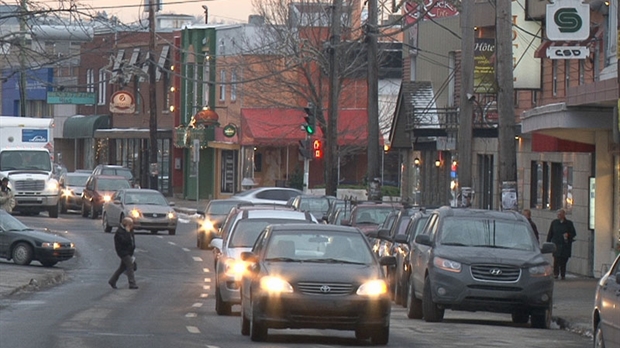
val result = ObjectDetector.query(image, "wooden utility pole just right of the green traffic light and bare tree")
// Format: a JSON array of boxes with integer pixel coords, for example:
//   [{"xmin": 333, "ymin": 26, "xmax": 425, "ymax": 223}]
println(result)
[{"xmin": 366, "ymin": 0, "xmax": 381, "ymax": 199}]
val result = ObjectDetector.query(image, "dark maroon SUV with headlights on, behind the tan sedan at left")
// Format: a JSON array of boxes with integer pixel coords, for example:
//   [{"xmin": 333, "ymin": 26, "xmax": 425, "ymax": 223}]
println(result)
[{"xmin": 82, "ymin": 175, "xmax": 130, "ymax": 219}]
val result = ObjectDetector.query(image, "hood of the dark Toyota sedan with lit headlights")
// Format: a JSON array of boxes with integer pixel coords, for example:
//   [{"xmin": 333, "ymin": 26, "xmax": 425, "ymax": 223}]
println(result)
[{"xmin": 265, "ymin": 262, "xmax": 383, "ymax": 284}]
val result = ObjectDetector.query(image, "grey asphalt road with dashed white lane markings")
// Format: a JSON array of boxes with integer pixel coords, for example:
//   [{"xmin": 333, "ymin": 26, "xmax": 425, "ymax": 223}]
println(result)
[{"xmin": 0, "ymin": 214, "xmax": 592, "ymax": 348}]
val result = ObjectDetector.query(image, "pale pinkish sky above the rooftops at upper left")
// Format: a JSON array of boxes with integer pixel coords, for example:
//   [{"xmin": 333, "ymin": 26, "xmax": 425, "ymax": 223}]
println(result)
[{"xmin": 79, "ymin": 0, "xmax": 253, "ymax": 23}]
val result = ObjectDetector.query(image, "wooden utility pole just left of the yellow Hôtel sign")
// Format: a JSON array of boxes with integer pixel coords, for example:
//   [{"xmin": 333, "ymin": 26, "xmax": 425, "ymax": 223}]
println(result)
[{"xmin": 458, "ymin": 0, "xmax": 474, "ymax": 206}]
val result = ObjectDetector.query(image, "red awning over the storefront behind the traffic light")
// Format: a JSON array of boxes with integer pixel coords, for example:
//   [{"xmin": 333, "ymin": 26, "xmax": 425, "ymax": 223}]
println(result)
[{"xmin": 240, "ymin": 108, "xmax": 370, "ymax": 146}]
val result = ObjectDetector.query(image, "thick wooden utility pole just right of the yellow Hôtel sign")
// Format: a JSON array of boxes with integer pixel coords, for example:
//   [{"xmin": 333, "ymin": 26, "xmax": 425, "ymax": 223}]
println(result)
[{"xmin": 495, "ymin": 0, "xmax": 517, "ymax": 201}]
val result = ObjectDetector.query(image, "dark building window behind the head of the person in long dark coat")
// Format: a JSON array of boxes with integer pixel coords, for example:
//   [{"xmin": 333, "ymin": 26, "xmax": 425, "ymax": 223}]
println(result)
[{"xmin": 530, "ymin": 161, "xmax": 573, "ymax": 212}]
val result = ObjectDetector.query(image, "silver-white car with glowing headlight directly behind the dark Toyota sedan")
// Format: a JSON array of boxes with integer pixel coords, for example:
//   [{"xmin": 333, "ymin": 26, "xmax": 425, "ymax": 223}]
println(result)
[{"xmin": 211, "ymin": 206, "xmax": 318, "ymax": 315}]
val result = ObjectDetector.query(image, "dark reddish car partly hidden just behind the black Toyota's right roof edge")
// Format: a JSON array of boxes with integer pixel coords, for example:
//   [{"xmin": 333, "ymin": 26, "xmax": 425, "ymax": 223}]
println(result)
[{"xmin": 340, "ymin": 201, "xmax": 402, "ymax": 235}]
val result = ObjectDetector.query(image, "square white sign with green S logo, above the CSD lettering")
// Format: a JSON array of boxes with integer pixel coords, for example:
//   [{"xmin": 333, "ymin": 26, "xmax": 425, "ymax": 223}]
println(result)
[{"xmin": 547, "ymin": 0, "xmax": 590, "ymax": 41}]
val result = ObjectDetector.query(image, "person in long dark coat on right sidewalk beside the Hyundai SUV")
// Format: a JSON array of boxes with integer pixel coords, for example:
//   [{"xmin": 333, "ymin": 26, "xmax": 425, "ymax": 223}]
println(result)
[{"xmin": 547, "ymin": 209, "xmax": 577, "ymax": 279}]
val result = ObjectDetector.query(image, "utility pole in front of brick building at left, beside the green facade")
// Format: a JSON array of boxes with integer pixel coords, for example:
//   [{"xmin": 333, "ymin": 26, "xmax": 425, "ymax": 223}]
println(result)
[{"xmin": 149, "ymin": 0, "xmax": 159, "ymax": 190}]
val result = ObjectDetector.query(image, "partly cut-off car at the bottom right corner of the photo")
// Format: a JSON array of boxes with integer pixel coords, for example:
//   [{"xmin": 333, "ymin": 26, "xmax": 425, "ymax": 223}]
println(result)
[{"xmin": 592, "ymin": 255, "xmax": 620, "ymax": 348}]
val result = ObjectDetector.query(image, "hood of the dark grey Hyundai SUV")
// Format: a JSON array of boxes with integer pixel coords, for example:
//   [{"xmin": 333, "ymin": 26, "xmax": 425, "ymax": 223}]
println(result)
[{"xmin": 434, "ymin": 246, "xmax": 547, "ymax": 267}]
